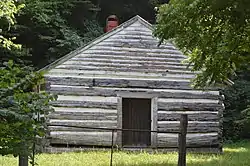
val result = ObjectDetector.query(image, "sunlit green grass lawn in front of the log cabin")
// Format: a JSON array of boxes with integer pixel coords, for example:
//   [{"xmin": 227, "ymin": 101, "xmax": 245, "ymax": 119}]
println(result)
[{"xmin": 0, "ymin": 142, "xmax": 250, "ymax": 166}]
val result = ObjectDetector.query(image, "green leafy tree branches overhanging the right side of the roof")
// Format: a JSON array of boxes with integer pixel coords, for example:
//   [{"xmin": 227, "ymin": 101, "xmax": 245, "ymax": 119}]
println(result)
[{"xmin": 155, "ymin": 0, "xmax": 250, "ymax": 87}]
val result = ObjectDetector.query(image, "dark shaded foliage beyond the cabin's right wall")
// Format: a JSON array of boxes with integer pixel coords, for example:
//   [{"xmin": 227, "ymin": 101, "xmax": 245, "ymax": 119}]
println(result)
[{"xmin": 223, "ymin": 74, "xmax": 250, "ymax": 141}]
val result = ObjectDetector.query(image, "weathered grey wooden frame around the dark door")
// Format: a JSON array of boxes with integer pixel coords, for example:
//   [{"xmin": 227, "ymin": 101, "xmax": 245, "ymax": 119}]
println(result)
[{"xmin": 116, "ymin": 92, "xmax": 158, "ymax": 148}]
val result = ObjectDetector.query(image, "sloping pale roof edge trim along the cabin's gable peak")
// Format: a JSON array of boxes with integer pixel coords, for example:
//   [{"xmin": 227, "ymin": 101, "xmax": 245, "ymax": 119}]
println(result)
[{"xmin": 40, "ymin": 15, "xmax": 153, "ymax": 71}]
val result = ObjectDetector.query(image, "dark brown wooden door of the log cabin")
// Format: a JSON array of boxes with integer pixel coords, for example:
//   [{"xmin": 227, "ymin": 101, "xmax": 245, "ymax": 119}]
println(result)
[{"xmin": 122, "ymin": 98, "xmax": 151, "ymax": 147}]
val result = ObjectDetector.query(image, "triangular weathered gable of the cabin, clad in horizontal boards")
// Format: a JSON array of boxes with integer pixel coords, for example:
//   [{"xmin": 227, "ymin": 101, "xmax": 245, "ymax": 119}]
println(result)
[{"xmin": 44, "ymin": 16, "xmax": 195, "ymax": 85}]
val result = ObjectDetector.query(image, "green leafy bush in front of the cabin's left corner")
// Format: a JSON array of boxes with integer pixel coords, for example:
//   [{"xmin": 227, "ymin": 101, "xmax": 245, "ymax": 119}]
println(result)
[{"xmin": 0, "ymin": 61, "xmax": 55, "ymax": 159}]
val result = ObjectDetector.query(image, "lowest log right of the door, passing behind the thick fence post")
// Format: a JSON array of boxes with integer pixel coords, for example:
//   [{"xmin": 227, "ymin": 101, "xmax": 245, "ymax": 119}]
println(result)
[{"xmin": 157, "ymin": 133, "xmax": 219, "ymax": 148}]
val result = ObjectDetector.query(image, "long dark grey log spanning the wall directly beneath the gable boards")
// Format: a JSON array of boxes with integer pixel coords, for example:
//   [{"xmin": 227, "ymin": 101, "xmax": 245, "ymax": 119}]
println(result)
[{"xmin": 46, "ymin": 77, "xmax": 192, "ymax": 89}]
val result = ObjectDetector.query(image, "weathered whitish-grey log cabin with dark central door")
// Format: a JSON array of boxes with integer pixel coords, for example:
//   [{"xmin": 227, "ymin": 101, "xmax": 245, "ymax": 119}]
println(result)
[{"xmin": 44, "ymin": 16, "xmax": 224, "ymax": 152}]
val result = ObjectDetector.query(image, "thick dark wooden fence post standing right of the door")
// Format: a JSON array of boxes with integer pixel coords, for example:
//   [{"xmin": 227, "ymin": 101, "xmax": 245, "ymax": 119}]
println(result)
[{"xmin": 178, "ymin": 114, "xmax": 188, "ymax": 166}]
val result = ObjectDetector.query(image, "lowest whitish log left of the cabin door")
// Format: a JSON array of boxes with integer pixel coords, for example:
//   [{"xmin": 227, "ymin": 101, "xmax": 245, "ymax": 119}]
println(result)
[{"xmin": 50, "ymin": 132, "xmax": 117, "ymax": 146}]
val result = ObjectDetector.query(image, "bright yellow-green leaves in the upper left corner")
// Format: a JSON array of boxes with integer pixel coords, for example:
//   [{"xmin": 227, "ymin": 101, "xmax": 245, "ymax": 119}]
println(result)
[{"xmin": 0, "ymin": 0, "xmax": 24, "ymax": 50}]
